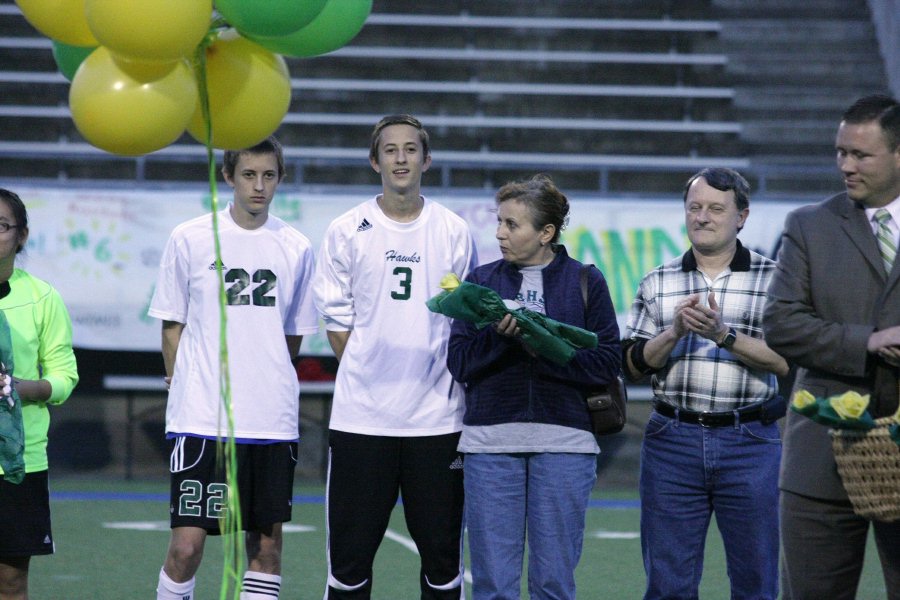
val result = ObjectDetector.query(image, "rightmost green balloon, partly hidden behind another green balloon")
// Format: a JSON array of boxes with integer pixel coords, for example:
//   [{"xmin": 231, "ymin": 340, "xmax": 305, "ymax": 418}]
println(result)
[{"xmin": 248, "ymin": 0, "xmax": 372, "ymax": 57}]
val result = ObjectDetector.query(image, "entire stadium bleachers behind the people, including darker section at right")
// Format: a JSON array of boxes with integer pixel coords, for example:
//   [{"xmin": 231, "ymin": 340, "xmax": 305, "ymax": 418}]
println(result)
[{"xmin": 0, "ymin": 0, "xmax": 885, "ymax": 194}]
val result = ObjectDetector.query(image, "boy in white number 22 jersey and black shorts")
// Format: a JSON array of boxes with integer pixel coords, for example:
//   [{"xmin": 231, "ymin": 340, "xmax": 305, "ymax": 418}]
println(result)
[{"xmin": 149, "ymin": 137, "xmax": 318, "ymax": 600}]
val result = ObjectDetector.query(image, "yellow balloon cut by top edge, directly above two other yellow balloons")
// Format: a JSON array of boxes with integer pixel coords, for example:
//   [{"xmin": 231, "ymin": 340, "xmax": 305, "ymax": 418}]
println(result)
[{"xmin": 85, "ymin": 0, "xmax": 212, "ymax": 61}]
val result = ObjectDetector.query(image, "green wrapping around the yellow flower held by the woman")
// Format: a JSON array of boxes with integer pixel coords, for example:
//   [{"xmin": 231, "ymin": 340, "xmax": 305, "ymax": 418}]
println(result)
[{"xmin": 425, "ymin": 281, "xmax": 597, "ymax": 365}]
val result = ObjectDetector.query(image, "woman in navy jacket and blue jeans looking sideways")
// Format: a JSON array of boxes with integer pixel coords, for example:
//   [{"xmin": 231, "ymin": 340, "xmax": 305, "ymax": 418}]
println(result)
[{"xmin": 448, "ymin": 175, "xmax": 620, "ymax": 600}]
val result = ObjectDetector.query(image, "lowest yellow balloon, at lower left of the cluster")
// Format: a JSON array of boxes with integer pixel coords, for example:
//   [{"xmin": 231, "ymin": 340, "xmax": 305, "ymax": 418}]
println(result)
[{"xmin": 69, "ymin": 46, "xmax": 197, "ymax": 156}]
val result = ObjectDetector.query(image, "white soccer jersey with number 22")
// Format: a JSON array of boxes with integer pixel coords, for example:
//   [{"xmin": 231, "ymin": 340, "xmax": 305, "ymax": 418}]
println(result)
[{"xmin": 148, "ymin": 207, "xmax": 318, "ymax": 440}]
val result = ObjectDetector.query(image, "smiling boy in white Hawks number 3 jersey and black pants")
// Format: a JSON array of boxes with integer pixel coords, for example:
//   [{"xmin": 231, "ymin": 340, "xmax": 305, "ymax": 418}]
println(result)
[{"xmin": 313, "ymin": 115, "xmax": 476, "ymax": 599}]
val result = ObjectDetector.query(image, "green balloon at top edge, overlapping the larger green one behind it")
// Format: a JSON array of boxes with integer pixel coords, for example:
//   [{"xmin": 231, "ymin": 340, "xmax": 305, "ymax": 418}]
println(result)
[{"xmin": 216, "ymin": 0, "xmax": 327, "ymax": 37}]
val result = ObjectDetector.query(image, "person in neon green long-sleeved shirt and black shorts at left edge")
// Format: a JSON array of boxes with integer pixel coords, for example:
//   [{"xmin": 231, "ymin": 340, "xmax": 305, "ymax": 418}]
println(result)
[{"xmin": 0, "ymin": 188, "xmax": 78, "ymax": 600}]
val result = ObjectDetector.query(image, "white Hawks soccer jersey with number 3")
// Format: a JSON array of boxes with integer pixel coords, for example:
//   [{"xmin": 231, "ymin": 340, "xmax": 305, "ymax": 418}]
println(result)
[{"xmin": 313, "ymin": 198, "xmax": 476, "ymax": 436}]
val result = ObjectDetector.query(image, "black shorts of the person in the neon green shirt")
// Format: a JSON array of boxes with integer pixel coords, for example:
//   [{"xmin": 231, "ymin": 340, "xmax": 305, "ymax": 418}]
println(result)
[{"xmin": 0, "ymin": 471, "xmax": 54, "ymax": 558}]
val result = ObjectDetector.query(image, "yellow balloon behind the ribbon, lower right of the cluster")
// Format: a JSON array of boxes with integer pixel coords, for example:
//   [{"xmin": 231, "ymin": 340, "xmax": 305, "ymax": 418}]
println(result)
[{"xmin": 188, "ymin": 29, "xmax": 291, "ymax": 150}]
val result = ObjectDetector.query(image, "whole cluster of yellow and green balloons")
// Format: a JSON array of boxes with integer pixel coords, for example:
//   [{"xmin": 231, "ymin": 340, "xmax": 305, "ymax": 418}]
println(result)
[{"xmin": 15, "ymin": 0, "xmax": 372, "ymax": 156}]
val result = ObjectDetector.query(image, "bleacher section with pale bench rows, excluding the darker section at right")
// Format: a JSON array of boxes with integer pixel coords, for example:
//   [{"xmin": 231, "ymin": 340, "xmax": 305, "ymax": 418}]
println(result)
[{"xmin": 0, "ymin": 1, "xmax": 746, "ymax": 189}]
